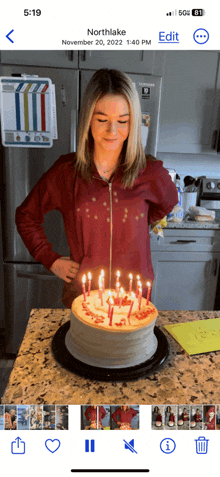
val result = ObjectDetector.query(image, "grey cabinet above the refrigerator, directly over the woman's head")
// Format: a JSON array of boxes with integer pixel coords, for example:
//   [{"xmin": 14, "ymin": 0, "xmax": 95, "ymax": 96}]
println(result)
[{"xmin": 79, "ymin": 50, "xmax": 165, "ymax": 76}]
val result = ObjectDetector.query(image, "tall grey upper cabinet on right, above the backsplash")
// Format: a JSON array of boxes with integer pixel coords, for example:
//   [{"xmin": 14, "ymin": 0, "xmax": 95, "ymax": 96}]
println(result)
[{"xmin": 157, "ymin": 51, "xmax": 220, "ymax": 154}]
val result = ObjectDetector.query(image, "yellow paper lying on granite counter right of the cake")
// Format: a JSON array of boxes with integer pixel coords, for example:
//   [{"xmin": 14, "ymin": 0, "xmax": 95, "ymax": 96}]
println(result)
[{"xmin": 164, "ymin": 318, "xmax": 220, "ymax": 355}]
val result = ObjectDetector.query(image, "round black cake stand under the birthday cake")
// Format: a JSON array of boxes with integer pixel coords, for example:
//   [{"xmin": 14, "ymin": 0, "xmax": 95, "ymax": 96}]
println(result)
[{"xmin": 52, "ymin": 321, "xmax": 169, "ymax": 382}]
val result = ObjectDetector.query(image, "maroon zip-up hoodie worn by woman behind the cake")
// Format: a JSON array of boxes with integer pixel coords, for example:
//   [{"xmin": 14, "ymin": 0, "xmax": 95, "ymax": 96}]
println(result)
[{"xmin": 16, "ymin": 153, "xmax": 178, "ymax": 307}]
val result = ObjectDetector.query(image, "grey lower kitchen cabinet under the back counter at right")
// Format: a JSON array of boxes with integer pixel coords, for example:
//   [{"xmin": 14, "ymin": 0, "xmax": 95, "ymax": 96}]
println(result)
[{"xmin": 151, "ymin": 229, "xmax": 220, "ymax": 311}]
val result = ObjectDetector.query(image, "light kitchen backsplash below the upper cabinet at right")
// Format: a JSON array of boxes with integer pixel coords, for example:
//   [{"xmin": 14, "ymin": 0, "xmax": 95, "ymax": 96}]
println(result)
[{"xmin": 157, "ymin": 152, "xmax": 220, "ymax": 189}]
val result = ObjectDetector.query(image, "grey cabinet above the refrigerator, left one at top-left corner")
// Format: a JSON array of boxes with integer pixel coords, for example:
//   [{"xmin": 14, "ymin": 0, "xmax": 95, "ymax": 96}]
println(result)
[{"xmin": 1, "ymin": 50, "xmax": 78, "ymax": 68}]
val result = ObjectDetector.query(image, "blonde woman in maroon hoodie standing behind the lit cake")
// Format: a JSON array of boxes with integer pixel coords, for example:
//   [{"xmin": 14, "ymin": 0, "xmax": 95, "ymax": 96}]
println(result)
[{"xmin": 16, "ymin": 69, "xmax": 178, "ymax": 307}]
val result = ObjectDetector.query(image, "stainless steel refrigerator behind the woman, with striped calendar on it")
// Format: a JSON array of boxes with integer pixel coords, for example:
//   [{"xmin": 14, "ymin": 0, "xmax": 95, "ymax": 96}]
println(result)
[{"xmin": 0, "ymin": 60, "xmax": 161, "ymax": 353}]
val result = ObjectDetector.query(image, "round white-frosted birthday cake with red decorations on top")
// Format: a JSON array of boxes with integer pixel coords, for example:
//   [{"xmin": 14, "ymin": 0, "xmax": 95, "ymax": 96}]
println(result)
[{"xmin": 65, "ymin": 290, "xmax": 158, "ymax": 368}]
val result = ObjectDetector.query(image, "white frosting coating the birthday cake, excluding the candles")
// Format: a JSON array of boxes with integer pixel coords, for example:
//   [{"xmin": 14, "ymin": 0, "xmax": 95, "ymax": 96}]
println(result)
[{"xmin": 65, "ymin": 286, "xmax": 157, "ymax": 368}]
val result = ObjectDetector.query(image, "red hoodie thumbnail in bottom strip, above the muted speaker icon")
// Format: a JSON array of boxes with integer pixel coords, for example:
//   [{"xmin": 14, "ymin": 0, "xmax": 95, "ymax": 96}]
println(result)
[{"xmin": 111, "ymin": 405, "xmax": 139, "ymax": 431}]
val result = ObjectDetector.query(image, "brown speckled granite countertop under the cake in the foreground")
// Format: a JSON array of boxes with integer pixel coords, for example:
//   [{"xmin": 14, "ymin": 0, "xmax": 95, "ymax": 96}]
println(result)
[{"xmin": 2, "ymin": 309, "xmax": 220, "ymax": 405}]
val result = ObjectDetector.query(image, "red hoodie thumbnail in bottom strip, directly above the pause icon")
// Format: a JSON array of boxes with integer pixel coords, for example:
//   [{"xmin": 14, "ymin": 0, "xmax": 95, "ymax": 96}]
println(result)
[{"xmin": 81, "ymin": 405, "xmax": 110, "ymax": 431}]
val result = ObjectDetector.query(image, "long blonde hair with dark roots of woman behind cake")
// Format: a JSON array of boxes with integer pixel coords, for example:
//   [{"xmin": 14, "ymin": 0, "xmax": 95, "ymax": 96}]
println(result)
[{"xmin": 76, "ymin": 68, "xmax": 146, "ymax": 188}]
